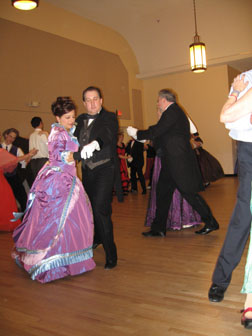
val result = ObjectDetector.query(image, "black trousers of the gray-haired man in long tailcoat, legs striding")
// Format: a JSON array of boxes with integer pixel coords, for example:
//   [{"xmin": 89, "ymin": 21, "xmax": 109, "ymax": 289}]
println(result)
[{"xmin": 151, "ymin": 163, "xmax": 213, "ymax": 232}]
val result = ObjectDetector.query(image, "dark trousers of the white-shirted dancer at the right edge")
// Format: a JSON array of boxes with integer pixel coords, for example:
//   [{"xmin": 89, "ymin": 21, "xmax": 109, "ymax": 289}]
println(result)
[{"xmin": 212, "ymin": 142, "xmax": 252, "ymax": 288}]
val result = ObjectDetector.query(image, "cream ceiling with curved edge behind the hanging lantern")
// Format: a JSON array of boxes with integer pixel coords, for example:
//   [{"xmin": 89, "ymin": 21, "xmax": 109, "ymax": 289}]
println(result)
[{"xmin": 41, "ymin": 0, "xmax": 252, "ymax": 77}]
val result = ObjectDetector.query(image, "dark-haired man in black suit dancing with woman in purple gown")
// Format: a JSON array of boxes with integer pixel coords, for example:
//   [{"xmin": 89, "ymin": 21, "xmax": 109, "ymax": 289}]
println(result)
[{"xmin": 74, "ymin": 87, "xmax": 122, "ymax": 269}]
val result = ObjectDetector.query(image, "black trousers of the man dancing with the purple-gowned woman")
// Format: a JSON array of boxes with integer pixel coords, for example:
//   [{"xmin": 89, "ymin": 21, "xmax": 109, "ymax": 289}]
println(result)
[{"xmin": 82, "ymin": 163, "xmax": 117, "ymax": 262}]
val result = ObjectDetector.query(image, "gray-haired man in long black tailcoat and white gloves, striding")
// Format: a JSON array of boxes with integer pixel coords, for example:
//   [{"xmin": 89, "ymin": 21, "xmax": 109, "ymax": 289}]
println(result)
[{"xmin": 127, "ymin": 89, "xmax": 219, "ymax": 237}]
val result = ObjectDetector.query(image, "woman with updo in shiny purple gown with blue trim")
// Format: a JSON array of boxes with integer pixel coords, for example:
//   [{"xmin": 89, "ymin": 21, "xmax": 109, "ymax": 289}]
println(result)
[{"xmin": 13, "ymin": 97, "xmax": 95, "ymax": 283}]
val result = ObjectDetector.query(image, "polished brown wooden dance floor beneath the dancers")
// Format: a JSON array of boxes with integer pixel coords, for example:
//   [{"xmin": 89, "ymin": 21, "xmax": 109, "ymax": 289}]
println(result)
[{"xmin": 0, "ymin": 177, "xmax": 249, "ymax": 336}]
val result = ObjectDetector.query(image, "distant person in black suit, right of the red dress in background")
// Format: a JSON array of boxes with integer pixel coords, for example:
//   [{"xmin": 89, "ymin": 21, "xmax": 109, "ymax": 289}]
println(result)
[{"xmin": 126, "ymin": 139, "xmax": 146, "ymax": 194}]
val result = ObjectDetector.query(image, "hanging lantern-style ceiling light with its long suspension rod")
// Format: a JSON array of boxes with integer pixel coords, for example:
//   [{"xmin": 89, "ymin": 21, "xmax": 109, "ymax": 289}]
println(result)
[{"xmin": 189, "ymin": 0, "xmax": 207, "ymax": 73}]
